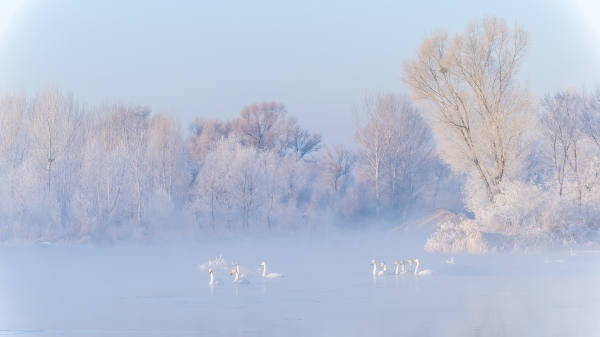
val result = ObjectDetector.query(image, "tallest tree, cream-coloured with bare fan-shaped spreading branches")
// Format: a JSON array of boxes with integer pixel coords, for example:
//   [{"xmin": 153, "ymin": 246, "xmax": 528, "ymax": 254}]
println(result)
[{"xmin": 402, "ymin": 17, "xmax": 534, "ymax": 200}]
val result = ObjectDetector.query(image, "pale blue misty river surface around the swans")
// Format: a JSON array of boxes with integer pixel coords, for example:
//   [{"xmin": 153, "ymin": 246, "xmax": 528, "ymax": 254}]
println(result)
[{"xmin": 0, "ymin": 234, "xmax": 600, "ymax": 337}]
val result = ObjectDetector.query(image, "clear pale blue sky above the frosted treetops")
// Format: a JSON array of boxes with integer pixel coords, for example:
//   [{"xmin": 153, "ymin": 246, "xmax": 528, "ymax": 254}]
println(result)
[{"xmin": 0, "ymin": 0, "xmax": 600, "ymax": 143}]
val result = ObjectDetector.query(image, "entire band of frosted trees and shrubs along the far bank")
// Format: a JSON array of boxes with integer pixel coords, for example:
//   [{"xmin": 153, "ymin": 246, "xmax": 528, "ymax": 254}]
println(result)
[{"xmin": 0, "ymin": 17, "xmax": 600, "ymax": 252}]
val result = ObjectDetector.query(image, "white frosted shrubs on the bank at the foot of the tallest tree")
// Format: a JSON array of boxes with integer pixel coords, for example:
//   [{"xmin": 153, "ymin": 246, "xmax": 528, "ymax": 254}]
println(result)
[{"xmin": 434, "ymin": 181, "xmax": 584, "ymax": 253}]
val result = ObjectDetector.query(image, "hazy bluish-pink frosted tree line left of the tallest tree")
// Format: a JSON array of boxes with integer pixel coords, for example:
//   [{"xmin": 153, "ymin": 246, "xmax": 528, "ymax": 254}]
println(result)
[{"xmin": 0, "ymin": 86, "xmax": 443, "ymax": 242}]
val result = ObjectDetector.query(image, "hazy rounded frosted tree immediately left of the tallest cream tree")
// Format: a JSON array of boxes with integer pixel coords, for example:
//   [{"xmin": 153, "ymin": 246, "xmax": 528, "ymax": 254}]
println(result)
[{"xmin": 355, "ymin": 93, "xmax": 433, "ymax": 215}]
